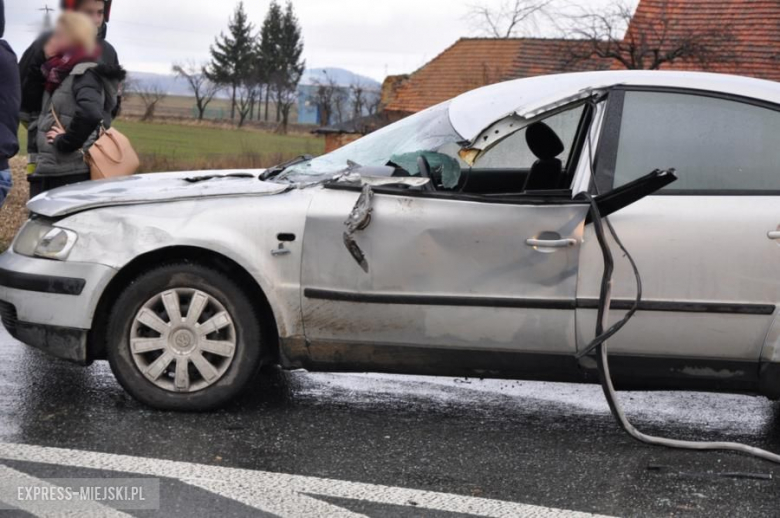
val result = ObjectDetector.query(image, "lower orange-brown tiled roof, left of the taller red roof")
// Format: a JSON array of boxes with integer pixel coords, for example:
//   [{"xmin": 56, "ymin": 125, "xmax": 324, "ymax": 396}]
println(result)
[{"xmin": 385, "ymin": 38, "xmax": 610, "ymax": 113}]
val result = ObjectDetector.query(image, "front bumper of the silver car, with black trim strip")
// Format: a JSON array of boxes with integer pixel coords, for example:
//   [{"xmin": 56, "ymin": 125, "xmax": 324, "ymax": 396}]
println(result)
[{"xmin": 0, "ymin": 251, "xmax": 116, "ymax": 364}]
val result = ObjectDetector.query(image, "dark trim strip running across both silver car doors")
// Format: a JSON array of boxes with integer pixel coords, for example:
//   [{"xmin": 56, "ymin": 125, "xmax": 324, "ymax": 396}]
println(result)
[{"xmin": 303, "ymin": 288, "xmax": 775, "ymax": 315}]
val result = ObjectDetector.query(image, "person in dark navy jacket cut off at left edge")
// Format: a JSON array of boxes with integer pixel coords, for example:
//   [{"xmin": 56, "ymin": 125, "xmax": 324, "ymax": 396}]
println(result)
[{"xmin": 0, "ymin": 0, "xmax": 22, "ymax": 207}]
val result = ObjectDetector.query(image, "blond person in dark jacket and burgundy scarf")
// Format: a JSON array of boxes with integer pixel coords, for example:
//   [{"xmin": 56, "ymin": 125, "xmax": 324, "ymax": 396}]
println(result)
[{"xmin": 29, "ymin": 12, "xmax": 125, "ymax": 197}]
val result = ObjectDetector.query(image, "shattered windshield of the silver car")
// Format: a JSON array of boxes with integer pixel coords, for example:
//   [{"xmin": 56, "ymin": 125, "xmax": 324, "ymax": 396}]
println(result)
[{"xmin": 285, "ymin": 102, "xmax": 464, "ymax": 181}]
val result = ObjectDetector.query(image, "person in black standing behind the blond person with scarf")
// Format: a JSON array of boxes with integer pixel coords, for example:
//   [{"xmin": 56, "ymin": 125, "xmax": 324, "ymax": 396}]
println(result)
[{"xmin": 19, "ymin": 0, "xmax": 121, "ymax": 183}]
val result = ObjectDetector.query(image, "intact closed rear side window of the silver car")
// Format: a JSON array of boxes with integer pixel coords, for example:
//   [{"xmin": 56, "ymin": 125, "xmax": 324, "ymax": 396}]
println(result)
[{"xmin": 614, "ymin": 91, "xmax": 780, "ymax": 194}]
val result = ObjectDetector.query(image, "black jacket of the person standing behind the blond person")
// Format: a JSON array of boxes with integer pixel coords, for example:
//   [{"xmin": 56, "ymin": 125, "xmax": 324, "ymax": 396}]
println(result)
[{"xmin": 19, "ymin": 31, "xmax": 119, "ymax": 122}]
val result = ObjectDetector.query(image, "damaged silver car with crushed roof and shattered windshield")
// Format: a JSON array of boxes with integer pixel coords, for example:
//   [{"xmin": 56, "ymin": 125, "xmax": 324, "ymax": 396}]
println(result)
[{"xmin": 0, "ymin": 72, "xmax": 780, "ymax": 410}]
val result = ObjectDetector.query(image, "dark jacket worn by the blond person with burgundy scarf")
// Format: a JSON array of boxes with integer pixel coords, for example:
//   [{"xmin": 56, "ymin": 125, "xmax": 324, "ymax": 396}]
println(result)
[{"xmin": 54, "ymin": 63, "xmax": 127, "ymax": 153}]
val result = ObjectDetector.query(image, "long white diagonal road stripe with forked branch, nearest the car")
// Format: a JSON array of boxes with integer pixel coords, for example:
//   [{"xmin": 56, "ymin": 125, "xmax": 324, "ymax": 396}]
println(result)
[{"xmin": 0, "ymin": 443, "xmax": 612, "ymax": 518}]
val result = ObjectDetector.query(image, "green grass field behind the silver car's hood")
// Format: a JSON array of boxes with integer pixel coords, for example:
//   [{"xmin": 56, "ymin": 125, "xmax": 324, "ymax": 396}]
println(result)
[{"xmin": 19, "ymin": 120, "xmax": 325, "ymax": 172}]
